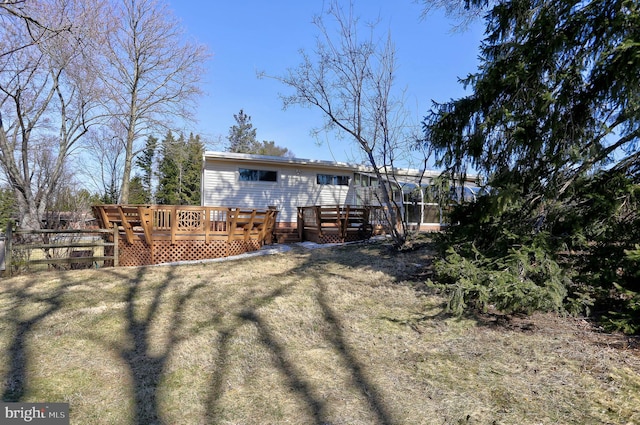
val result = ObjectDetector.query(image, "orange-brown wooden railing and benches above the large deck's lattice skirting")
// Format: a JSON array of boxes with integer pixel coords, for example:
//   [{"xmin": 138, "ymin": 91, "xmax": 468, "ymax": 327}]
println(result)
[{"xmin": 93, "ymin": 205, "xmax": 277, "ymax": 245}]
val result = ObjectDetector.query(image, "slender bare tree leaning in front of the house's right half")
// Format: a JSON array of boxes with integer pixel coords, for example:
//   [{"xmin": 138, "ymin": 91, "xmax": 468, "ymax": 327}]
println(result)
[{"xmin": 264, "ymin": 2, "xmax": 415, "ymax": 248}]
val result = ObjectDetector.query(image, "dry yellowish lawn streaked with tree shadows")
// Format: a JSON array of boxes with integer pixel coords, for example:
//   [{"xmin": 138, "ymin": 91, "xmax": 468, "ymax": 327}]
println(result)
[{"xmin": 0, "ymin": 238, "xmax": 640, "ymax": 425}]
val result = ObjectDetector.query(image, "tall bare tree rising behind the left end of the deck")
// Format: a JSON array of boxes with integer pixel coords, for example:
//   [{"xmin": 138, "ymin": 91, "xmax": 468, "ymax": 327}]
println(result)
[{"xmin": 104, "ymin": 0, "xmax": 209, "ymax": 203}]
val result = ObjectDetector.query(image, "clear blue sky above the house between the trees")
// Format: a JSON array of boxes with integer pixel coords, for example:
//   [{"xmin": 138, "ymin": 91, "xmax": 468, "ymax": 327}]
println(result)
[{"xmin": 168, "ymin": 0, "xmax": 482, "ymax": 166}]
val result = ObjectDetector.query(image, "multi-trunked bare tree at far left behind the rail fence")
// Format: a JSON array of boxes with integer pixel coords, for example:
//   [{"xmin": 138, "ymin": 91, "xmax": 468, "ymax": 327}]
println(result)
[{"xmin": 0, "ymin": 0, "xmax": 109, "ymax": 228}]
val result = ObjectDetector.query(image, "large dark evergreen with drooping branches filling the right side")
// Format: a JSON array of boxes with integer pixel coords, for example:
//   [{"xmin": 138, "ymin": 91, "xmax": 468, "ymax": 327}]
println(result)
[{"xmin": 425, "ymin": 0, "xmax": 640, "ymax": 329}]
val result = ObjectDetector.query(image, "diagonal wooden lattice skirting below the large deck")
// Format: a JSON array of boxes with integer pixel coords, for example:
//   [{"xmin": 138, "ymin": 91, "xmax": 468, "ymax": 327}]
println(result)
[{"xmin": 118, "ymin": 237, "xmax": 260, "ymax": 267}]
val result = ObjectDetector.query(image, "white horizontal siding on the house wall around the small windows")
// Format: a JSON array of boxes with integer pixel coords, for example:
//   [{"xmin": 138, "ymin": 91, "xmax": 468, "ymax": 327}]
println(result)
[{"xmin": 202, "ymin": 158, "xmax": 354, "ymax": 222}]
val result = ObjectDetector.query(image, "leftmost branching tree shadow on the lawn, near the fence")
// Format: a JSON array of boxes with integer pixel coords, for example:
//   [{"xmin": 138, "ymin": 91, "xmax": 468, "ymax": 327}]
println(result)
[{"xmin": 2, "ymin": 275, "xmax": 69, "ymax": 402}]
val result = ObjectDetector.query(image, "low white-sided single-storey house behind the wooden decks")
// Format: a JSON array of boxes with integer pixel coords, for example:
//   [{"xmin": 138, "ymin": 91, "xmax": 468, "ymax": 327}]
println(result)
[{"xmin": 201, "ymin": 151, "xmax": 478, "ymax": 238}]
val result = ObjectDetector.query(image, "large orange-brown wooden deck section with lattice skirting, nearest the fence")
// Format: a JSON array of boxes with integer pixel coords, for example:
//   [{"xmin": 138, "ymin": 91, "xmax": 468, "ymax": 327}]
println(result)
[{"xmin": 93, "ymin": 205, "xmax": 278, "ymax": 266}]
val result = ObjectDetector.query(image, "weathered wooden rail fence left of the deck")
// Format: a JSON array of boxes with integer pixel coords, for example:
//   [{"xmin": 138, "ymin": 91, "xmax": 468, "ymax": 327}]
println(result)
[{"xmin": 4, "ymin": 224, "xmax": 118, "ymax": 276}]
